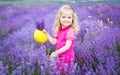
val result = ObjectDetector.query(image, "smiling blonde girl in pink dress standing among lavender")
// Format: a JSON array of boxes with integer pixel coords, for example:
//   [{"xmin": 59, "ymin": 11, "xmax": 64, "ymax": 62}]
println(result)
[{"xmin": 47, "ymin": 5, "xmax": 78, "ymax": 69}]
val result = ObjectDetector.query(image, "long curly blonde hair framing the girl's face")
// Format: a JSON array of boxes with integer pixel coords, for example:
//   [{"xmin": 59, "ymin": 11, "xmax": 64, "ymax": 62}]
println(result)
[{"xmin": 53, "ymin": 5, "xmax": 79, "ymax": 35}]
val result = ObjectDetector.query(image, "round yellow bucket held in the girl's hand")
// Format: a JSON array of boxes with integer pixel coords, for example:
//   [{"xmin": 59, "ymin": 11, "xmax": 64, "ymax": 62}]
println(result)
[{"xmin": 34, "ymin": 29, "xmax": 48, "ymax": 44}]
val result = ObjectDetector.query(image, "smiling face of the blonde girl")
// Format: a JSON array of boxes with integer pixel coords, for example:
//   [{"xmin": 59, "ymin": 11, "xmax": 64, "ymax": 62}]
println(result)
[{"xmin": 60, "ymin": 10, "xmax": 73, "ymax": 28}]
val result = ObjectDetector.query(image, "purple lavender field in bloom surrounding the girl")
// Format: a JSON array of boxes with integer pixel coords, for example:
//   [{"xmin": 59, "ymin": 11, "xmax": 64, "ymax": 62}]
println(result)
[{"xmin": 0, "ymin": 3, "xmax": 120, "ymax": 75}]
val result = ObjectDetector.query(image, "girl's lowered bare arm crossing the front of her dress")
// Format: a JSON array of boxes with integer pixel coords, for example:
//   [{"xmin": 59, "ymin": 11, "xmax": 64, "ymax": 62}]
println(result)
[{"xmin": 50, "ymin": 40, "xmax": 72, "ymax": 58}]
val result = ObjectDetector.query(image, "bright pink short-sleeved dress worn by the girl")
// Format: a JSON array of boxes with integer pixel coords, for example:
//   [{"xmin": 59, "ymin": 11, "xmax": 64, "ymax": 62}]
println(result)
[{"xmin": 56, "ymin": 26, "xmax": 76, "ymax": 69}]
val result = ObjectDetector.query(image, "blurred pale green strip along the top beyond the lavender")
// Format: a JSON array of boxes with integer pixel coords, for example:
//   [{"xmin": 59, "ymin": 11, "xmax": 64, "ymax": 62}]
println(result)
[{"xmin": 0, "ymin": 0, "xmax": 120, "ymax": 4}]
